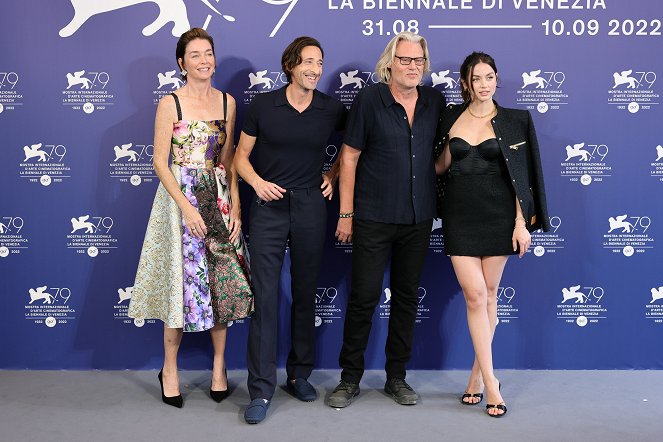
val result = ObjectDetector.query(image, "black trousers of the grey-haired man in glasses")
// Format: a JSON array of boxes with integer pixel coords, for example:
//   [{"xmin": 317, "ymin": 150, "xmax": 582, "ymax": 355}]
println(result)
[{"xmin": 339, "ymin": 219, "xmax": 432, "ymax": 383}]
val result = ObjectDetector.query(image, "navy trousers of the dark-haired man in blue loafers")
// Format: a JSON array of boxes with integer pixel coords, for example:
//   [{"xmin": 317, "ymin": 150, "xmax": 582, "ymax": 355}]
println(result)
[{"xmin": 247, "ymin": 188, "xmax": 327, "ymax": 400}]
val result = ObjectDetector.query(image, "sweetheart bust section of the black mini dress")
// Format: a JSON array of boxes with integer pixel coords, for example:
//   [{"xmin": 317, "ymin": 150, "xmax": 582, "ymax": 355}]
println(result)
[{"xmin": 449, "ymin": 137, "xmax": 507, "ymax": 175}]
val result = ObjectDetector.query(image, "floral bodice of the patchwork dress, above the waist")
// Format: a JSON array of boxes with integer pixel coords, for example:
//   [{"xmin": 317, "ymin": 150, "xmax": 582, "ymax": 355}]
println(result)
[{"xmin": 171, "ymin": 120, "xmax": 226, "ymax": 169}]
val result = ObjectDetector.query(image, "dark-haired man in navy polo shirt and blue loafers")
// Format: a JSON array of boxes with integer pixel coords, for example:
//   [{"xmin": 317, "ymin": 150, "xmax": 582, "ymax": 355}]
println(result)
[{"xmin": 234, "ymin": 37, "xmax": 346, "ymax": 424}]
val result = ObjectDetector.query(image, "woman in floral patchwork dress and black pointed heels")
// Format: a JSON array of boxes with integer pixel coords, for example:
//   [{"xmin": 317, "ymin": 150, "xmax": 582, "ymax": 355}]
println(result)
[{"xmin": 129, "ymin": 28, "xmax": 253, "ymax": 407}]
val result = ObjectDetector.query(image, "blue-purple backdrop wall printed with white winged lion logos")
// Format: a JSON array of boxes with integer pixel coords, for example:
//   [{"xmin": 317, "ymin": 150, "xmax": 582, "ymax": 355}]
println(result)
[{"xmin": 0, "ymin": 0, "xmax": 663, "ymax": 369}]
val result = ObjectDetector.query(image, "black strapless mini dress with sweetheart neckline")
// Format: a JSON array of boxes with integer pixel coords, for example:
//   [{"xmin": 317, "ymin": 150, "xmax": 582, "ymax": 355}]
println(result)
[{"xmin": 442, "ymin": 137, "xmax": 516, "ymax": 256}]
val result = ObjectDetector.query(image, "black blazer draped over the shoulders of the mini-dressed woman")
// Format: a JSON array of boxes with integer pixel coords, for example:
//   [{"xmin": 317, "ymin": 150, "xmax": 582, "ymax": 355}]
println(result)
[{"xmin": 436, "ymin": 103, "xmax": 550, "ymax": 232}]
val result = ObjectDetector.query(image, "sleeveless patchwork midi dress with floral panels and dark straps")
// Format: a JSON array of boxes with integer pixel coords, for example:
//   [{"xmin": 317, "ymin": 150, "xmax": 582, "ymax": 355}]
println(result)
[{"xmin": 128, "ymin": 93, "xmax": 253, "ymax": 331}]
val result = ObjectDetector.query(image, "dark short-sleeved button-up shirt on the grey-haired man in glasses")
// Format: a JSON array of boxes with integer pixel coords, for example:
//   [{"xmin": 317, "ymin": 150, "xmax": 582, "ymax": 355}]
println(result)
[{"xmin": 343, "ymin": 83, "xmax": 445, "ymax": 224}]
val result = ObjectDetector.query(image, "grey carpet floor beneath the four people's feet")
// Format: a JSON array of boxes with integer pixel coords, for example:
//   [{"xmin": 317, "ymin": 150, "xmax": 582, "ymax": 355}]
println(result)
[{"xmin": 0, "ymin": 370, "xmax": 663, "ymax": 442}]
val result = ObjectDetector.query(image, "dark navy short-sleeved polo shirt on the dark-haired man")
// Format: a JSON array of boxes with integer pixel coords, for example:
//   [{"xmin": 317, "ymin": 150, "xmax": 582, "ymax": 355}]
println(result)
[{"xmin": 242, "ymin": 86, "xmax": 347, "ymax": 190}]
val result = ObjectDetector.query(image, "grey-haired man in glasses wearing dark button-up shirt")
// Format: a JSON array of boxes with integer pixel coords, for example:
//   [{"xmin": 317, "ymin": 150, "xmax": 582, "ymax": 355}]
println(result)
[{"xmin": 327, "ymin": 32, "xmax": 444, "ymax": 408}]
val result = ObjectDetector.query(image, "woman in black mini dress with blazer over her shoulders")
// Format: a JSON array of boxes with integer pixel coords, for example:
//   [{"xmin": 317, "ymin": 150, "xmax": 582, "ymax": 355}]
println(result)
[{"xmin": 435, "ymin": 52, "xmax": 549, "ymax": 417}]
